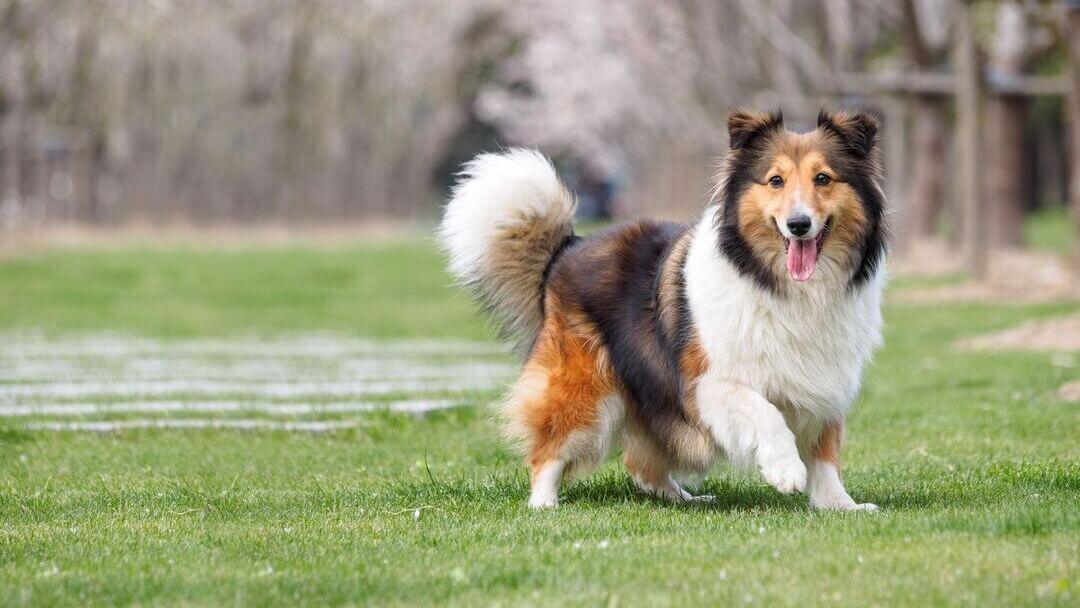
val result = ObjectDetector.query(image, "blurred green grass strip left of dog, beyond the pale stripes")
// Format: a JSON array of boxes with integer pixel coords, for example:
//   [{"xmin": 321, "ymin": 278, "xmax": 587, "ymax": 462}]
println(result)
[{"xmin": 0, "ymin": 241, "xmax": 486, "ymax": 338}]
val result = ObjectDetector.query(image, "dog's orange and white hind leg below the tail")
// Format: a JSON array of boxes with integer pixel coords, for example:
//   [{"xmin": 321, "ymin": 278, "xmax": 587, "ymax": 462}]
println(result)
[{"xmin": 507, "ymin": 314, "xmax": 623, "ymax": 509}]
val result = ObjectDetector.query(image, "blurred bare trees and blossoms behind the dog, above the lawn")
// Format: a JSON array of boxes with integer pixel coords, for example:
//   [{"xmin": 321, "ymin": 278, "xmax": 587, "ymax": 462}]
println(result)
[{"xmin": 0, "ymin": 0, "xmax": 1080, "ymax": 278}]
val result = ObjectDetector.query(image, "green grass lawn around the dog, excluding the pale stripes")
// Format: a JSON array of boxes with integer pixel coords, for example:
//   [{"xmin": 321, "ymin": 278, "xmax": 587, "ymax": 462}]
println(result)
[{"xmin": 0, "ymin": 234, "xmax": 1080, "ymax": 606}]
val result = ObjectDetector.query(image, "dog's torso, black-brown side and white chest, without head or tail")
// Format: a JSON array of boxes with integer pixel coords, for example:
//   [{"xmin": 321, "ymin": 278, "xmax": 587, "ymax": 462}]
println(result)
[{"xmin": 545, "ymin": 214, "xmax": 881, "ymax": 474}]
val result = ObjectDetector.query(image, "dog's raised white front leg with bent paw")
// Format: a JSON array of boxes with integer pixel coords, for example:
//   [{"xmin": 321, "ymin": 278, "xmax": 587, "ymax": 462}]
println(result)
[{"xmin": 696, "ymin": 374, "xmax": 807, "ymax": 494}]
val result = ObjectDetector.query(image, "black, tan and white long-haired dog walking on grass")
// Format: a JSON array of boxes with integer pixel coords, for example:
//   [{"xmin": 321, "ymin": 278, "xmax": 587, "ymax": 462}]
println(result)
[{"xmin": 438, "ymin": 109, "xmax": 887, "ymax": 510}]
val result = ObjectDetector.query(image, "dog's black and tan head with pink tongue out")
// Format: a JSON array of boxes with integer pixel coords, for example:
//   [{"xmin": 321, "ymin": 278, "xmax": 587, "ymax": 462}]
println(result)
[{"xmin": 716, "ymin": 110, "xmax": 885, "ymax": 293}]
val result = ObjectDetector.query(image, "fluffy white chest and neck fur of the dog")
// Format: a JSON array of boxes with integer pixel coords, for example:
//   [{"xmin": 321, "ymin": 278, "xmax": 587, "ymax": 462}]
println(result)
[{"xmin": 686, "ymin": 210, "xmax": 885, "ymax": 422}]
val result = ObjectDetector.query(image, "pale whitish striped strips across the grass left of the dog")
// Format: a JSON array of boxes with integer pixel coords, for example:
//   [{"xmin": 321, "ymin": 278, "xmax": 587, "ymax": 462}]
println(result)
[{"xmin": 0, "ymin": 333, "xmax": 516, "ymax": 431}]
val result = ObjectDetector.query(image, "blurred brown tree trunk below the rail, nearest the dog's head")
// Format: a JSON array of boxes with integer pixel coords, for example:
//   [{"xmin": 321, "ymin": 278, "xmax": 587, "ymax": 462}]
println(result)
[{"xmin": 907, "ymin": 95, "xmax": 949, "ymax": 239}]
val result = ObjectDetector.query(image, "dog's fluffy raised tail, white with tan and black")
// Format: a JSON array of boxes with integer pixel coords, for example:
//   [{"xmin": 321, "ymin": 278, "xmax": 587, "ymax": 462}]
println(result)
[{"xmin": 438, "ymin": 148, "xmax": 577, "ymax": 351}]
